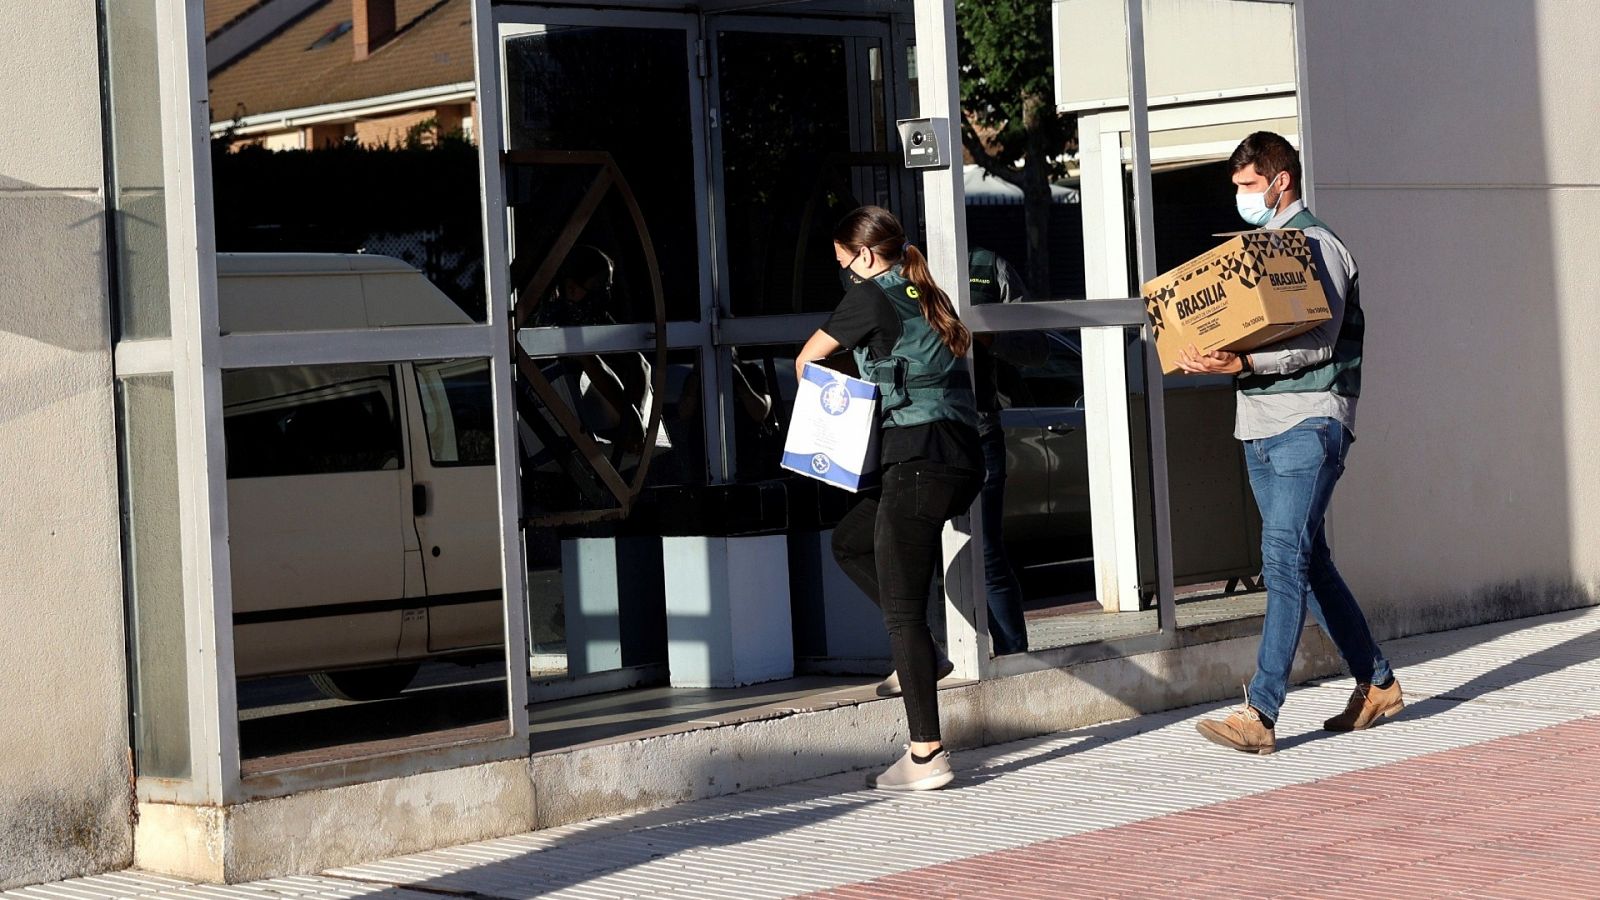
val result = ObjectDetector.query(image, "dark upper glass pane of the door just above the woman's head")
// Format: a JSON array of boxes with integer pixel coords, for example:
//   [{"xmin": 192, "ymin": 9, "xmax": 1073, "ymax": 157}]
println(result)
[{"xmin": 717, "ymin": 32, "xmax": 859, "ymax": 314}]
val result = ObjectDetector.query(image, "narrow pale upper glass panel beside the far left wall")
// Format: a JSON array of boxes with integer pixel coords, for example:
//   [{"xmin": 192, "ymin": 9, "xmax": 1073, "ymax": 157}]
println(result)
[{"xmin": 102, "ymin": 0, "xmax": 171, "ymax": 340}]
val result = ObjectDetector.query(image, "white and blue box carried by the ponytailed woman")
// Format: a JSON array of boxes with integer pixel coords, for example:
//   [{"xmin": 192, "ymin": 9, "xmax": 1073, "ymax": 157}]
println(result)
[{"xmin": 782, "ymin": 362, "xmax": 878, "ymax": 492}]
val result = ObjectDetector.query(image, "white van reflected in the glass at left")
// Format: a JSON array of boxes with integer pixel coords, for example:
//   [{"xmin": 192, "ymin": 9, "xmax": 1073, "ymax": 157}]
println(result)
[{"xmin": 218, "ymin": 253, "xmax": 504, "ymax": 700}]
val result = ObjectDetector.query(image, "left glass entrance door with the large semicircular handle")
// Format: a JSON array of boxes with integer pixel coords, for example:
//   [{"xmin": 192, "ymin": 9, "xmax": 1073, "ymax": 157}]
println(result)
[{"xmin": 496, "ymin": 6, "xmax": 720, "ymax": 701}]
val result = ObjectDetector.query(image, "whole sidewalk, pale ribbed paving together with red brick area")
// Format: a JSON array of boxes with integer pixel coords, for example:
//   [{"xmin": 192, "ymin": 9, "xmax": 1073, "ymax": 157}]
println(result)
[{"xmin": 12, "ymin": 610, "xmax": 1600, "ymax": 900}]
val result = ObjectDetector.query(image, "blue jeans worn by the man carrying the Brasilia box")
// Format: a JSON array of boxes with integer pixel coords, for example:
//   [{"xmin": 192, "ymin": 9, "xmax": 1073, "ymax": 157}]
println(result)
[{"xmin": 1245, "ymin": 418, "xmax": 1392, "ymax": 719}]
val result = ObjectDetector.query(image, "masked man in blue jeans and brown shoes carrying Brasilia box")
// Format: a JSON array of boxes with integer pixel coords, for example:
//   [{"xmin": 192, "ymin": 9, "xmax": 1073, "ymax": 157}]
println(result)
[{"xmin": 1179, "ymin": 131, "xmax": 1405, "ymax": 753}]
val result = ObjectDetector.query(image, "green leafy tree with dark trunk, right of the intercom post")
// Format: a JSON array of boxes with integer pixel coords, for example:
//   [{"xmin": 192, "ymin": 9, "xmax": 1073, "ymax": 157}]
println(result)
[{"xmin": 955, "ymin": 0, "xmax": 1077, "ymax": 291}]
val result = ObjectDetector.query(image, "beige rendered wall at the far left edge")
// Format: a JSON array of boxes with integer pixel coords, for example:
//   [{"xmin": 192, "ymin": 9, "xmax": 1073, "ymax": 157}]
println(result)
[{"xmin": 0, "ymin": 0, "xmax": 133, "ymax": 887}]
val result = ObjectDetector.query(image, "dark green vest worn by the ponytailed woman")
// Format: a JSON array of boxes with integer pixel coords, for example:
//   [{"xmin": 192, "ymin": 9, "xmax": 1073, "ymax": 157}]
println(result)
[{"xmin": 854, "ymin": 266, "xmax": 978, "ymax": 428}]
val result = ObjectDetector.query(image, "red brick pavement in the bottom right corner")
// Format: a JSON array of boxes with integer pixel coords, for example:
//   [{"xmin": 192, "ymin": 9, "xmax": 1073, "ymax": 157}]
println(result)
[{"xmin": 813, "ymin": 717, "xmax": 1600, "ymax": 900}]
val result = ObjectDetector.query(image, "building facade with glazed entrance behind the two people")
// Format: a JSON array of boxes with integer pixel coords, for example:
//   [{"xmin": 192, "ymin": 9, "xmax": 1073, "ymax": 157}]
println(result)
[{"xmin": 0, "ymin": 0, "xmax": 1600, "ymax": 887}]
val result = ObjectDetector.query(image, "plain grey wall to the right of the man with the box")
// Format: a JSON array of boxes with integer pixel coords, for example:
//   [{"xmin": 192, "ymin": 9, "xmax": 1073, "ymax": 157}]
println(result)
[{"xmin": 1302, "ymin": 0, "xmax": 1600, "ymax": 633}]
